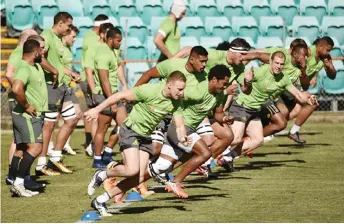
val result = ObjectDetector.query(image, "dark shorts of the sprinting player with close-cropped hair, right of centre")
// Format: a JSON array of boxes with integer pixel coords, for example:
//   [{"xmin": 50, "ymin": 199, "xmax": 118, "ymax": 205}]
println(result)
[{"xmin": 229, "ymin": 101, "xmax": 261, "ymax": 123}]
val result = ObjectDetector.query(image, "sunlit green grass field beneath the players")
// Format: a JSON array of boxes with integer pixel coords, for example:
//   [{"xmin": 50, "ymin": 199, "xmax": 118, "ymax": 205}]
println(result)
[{"xmin": 1, "ymin": 124, "xmax": 344, "ymax": 222}]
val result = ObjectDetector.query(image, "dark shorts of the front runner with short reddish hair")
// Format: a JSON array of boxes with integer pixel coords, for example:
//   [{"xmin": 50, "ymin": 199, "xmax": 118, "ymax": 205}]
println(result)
[{"xmin": 119, "ymin": 123, "xmax": 154, "ymax": 156}]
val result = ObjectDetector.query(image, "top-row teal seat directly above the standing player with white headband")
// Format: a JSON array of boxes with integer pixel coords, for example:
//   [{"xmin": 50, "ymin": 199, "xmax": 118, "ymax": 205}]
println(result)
[{"xmin": 83, "ymin": 0, "xmax": 111, "ymax": 19}]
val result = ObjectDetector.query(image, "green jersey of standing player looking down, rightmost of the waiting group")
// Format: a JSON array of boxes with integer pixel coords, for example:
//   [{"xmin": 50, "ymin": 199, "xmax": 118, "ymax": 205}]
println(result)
[{"xmin": 93, "ymin": 44, "xmax": 121, "ymax": 94}]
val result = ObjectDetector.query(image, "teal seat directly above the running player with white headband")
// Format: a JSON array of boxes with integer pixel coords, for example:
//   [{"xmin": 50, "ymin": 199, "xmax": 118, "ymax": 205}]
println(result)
[{"xmin": 231, "ymin": 16, "xmax": 259, "ymax": 42}]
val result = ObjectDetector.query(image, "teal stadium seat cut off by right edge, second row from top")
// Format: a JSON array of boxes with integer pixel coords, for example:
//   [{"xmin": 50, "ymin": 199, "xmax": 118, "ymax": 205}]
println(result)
[{"xmin": 322, "ymin": 16, "xmax": 344, "ymax": 45}]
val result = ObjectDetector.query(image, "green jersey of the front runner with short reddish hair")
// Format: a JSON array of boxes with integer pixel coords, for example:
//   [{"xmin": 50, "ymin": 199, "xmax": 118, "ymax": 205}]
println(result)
[{"xmin": 125, "ymin": 83, "xmax": 180, "ymax": 136}]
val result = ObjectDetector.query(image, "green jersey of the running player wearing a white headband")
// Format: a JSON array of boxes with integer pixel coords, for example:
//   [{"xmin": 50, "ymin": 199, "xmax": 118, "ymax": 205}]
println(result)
[{"xmin": 207, "ymin": 49, "xmax": 245, "ymax": 82}]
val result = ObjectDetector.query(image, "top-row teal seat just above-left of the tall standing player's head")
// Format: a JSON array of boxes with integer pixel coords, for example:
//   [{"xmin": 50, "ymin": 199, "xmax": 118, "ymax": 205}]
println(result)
[{"xmin": 31, "ymin": 0, "xmax": 59, "ymax": 29}]
